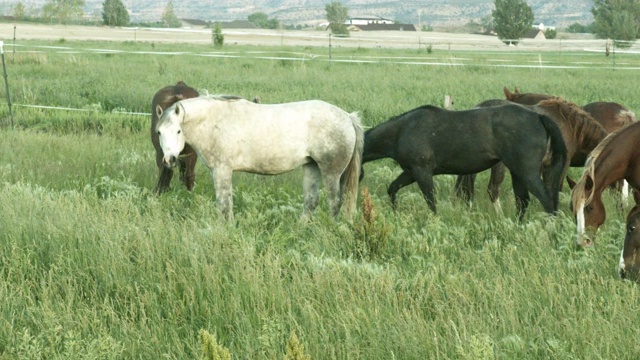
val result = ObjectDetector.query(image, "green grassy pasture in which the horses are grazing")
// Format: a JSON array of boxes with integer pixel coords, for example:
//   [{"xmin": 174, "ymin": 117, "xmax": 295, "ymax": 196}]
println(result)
[{"xmin": 0, "ymin": 39, "xmax": 640, "ymax": 359}]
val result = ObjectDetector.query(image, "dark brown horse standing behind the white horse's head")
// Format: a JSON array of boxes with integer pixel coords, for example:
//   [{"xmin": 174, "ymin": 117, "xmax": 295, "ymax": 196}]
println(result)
[{"xmin": 151, "ymin": 81, "xmax": 199, "ymax": 193}]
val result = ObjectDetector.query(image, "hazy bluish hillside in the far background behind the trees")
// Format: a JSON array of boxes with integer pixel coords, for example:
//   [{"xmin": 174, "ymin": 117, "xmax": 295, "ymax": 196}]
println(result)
[{"xmin": 0, "ymin": 0, "xmax": 593, "ymax": 27}]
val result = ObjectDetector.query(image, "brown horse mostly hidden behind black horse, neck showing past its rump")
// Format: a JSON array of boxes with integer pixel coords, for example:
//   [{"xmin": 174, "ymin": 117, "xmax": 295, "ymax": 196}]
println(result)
[{"xmin": 455, "ymin": 97, "xmax": 607, "ymax": 206}]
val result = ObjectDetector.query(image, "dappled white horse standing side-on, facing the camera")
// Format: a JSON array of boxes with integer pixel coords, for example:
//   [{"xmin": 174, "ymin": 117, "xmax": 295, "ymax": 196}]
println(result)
[{"xmin": 156, "ymin": 96, "xmax": 364, "ymax": 221}]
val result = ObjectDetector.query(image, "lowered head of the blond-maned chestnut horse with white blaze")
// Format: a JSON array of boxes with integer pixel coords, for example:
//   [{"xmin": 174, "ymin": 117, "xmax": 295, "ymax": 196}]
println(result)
[{"xmin": 569, "ymin": 172, "xmax": 606, "ymax": 247}]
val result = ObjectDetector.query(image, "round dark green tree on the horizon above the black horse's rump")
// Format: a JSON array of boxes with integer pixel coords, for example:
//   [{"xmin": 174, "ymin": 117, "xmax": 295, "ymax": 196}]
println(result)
[{"xmin": 491, "ymin": 0, "xmax": 534, "ymax": 45}]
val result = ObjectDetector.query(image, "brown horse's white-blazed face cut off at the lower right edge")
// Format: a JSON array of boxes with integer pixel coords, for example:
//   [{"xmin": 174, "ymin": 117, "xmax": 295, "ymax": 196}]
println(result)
[{"xmin": 618, "ymin": 190, "xmax": 640, "ymax": 282}]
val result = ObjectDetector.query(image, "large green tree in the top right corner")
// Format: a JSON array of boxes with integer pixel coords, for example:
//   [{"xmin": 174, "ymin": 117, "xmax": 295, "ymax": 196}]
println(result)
[{"xmin": 591, "ymin": 0, "xmax": 640, "ymax": 47}]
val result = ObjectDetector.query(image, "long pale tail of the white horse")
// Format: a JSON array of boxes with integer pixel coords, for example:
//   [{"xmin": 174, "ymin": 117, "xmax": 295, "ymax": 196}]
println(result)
[{"xmin": 340, "ymin": 113, "xmax": 364, "ymax": 218}]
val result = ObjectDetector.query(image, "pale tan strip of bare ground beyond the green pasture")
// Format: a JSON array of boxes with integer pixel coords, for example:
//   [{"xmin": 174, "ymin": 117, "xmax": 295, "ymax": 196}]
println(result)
[{"xmin": 0, "ymin": 23, "xmax": 640, "ymax": 53}]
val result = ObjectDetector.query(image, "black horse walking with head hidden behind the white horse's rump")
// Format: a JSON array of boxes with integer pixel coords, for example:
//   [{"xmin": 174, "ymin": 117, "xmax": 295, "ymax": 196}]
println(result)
[{"xmin": 362, "ymin": 105, "xmax": 567, "ymax": 220}]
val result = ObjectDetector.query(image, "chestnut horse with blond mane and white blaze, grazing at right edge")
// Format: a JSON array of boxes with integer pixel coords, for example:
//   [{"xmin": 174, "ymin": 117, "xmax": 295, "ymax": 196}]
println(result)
[{"xmin": 571, "ymin": 122, "xmax": 640, "ymax": 246}]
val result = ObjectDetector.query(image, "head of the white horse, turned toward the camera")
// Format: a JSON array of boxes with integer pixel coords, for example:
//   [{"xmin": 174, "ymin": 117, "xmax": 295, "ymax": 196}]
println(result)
[{"xmin": 156, "ymin": 103, "xmax": 185, "ymax": 167}]
